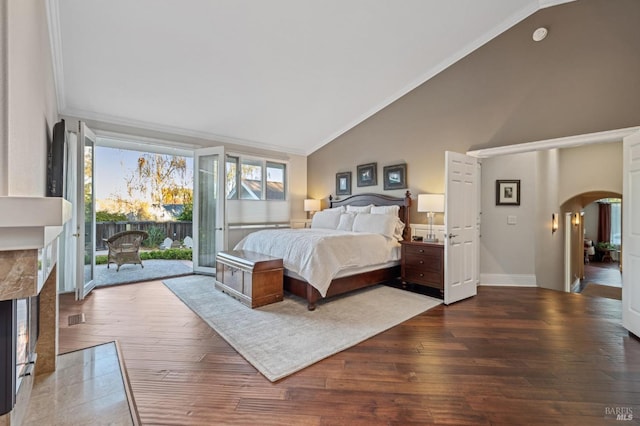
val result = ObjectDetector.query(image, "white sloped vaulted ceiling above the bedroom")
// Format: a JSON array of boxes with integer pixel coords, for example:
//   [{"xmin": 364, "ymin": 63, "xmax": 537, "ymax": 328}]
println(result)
[{"xmin": 48, "ymin": 0, "xmax": 566, "ymax": 155}]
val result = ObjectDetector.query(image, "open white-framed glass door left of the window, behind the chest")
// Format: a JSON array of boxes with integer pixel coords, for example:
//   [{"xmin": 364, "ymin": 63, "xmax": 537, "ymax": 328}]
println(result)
[{"xmin": 193, "ymin": 147, "xmax": 227, "ymax": 275}]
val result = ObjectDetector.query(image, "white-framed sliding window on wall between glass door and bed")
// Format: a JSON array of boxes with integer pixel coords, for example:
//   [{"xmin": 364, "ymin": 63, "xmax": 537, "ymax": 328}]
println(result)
[{"xmin": 225, "ymin": 155, "xmax": 287, "ymax": 200}]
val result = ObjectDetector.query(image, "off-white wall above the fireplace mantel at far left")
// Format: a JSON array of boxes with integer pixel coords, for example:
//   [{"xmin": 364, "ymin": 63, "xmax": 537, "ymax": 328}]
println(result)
[{"xmin": 0, "ymin": 0, "xmax": 58, "ymax": 196}]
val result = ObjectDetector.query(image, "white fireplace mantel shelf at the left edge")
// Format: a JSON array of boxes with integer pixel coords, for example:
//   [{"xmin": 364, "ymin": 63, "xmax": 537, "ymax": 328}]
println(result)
[{"xmin": 0, "ymin": 196, "xmax": 72, "ymax": 250}]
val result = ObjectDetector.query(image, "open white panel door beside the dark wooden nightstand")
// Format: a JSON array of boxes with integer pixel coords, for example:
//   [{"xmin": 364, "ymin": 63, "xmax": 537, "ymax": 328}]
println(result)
[{"xmin": 444, "ymin": 151, "xmax": 480, "ymax": 304}]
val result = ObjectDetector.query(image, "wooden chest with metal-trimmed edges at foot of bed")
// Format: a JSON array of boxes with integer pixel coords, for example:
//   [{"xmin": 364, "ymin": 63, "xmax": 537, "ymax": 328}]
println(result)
[{"xmin": 216, "ymin": 250, "xmax": 284, "ymax": 308}]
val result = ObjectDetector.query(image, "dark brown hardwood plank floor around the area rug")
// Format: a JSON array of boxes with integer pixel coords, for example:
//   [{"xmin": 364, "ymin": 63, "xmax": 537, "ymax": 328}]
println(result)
[{"xmin": 60, "ymin": 281, "xmax": 640, "ymax": 425}]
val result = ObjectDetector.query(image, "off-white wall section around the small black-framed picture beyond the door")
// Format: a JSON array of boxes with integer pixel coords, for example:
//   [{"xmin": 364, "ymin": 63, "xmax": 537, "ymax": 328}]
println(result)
[{"xmin": 480, "ymin": 153, "xmax": 536, "ymax": 286}]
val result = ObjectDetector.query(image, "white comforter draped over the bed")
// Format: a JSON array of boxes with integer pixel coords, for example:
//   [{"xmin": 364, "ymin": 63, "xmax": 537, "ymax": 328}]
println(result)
[{"xmin": 235, "ymin": 228, "xmax": 399, "ymax": 297}]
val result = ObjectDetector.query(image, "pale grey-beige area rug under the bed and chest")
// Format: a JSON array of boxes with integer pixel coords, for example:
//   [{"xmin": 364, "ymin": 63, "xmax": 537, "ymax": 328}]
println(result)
[{"xmin": 163, "ymin": 275, "xmax": 442, "ymax": 382}]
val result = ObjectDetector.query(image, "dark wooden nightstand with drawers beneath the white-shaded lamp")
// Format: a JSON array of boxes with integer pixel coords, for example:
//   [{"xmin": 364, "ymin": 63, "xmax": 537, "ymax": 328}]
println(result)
[{"xmin": 401, "ymin": 241, "xmax": 444, "ymax": 296}]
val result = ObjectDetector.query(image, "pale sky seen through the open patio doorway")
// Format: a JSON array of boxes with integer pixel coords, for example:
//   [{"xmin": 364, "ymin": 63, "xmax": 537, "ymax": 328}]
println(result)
[{"xmin": 94, "ymin": 146, "xmax": 193, "ymax": 200}]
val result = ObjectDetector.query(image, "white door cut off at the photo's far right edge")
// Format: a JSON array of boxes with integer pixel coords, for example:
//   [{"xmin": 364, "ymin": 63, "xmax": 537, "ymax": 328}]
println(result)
[{"xmin": 622, "ymin": 132, "xmax": 640, "ymax": 336}]
